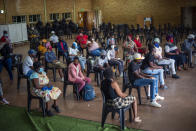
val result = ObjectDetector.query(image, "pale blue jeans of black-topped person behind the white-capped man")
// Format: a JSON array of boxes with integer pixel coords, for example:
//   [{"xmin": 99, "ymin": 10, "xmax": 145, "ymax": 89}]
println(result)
[{"xmin": 143, "ymin": 68, "xmax": 165, "ymax": 85}]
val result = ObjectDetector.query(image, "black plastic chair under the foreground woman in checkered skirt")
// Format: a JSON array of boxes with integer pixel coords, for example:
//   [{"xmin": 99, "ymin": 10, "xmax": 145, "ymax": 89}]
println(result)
[{"xmin": 101, "ymin": 84, "xmax": 132, "ymax": 130}]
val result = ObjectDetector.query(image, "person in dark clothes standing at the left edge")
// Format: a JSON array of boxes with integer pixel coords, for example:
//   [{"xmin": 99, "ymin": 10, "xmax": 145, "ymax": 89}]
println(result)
[{"xmin": 0, "ymin": 41, "xmax": 13, "ymax": 82}]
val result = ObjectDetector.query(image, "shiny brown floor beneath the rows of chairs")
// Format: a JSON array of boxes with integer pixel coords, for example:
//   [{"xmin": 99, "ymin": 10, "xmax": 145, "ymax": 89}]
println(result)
[{"xmin": 1, "ymin": 40, "xmax": 196, "ymax": 131}]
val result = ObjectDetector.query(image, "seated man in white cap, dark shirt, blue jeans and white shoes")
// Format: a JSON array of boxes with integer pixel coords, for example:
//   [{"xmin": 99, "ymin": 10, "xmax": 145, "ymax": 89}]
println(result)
[{"xmin": 128, "ymin": 53, "xmax": 164, "ymax": 107}]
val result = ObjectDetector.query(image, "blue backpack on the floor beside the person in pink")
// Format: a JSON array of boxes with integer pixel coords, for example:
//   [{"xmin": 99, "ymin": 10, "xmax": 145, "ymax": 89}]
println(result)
[{"xmin": 83, "ymin": 84, "xmax": 95, "ymax": 101}]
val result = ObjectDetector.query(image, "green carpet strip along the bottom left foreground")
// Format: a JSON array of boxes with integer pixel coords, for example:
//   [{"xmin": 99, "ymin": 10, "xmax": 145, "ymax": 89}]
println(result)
[{"xmin": 0, "ymin": 105, "xmax": 142, "ymax": 131}]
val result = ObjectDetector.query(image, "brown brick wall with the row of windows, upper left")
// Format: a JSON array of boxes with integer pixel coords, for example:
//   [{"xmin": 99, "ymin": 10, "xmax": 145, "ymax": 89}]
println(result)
[{"xmin": 0, "ymin": 0, "xmax": 92, "ymax": 24}]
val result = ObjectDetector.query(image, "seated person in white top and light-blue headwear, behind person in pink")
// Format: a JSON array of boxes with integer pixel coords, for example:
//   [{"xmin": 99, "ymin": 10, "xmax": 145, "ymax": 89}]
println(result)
[{"xmin": 68, "ymin": 42, "xmax": 86, "ymax": 71}]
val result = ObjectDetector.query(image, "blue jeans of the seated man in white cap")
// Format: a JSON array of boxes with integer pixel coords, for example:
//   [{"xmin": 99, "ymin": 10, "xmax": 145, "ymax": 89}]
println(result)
[{"xmin": 133, "ymin": 75, "xmax": 158, "ymax": 101}]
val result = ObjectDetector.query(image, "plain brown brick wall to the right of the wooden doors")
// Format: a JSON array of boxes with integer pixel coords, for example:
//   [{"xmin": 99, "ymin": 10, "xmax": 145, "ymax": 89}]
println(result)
[{"xmin": 93, "ymin": 0, "xmax": 196, "ymax": 25}]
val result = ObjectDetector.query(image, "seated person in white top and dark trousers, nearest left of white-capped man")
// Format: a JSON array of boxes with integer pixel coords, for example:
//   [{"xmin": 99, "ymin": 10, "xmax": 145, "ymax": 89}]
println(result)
[{"xmin": 107, "ymin": 45, "xmax": 124, "ymax": 77}]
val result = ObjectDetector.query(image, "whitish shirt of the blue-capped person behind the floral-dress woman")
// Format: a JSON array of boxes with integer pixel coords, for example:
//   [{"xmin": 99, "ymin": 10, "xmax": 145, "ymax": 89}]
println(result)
[{"xmin": 23, "ymin": 56, "xmax": 33, "ymax": 75}]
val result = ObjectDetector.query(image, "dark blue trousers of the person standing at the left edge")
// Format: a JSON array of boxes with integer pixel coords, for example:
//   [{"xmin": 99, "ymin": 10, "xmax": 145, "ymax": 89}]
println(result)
[{"xmin": 0, "ymin": 58, "xmax": 13, "ymax": 80}]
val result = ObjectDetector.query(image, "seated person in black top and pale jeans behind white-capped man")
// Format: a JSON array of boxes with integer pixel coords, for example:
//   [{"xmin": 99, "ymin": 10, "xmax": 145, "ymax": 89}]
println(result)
[{"xmin": 141, "ymin": 45, "xmax": 167, "ymax": 89}]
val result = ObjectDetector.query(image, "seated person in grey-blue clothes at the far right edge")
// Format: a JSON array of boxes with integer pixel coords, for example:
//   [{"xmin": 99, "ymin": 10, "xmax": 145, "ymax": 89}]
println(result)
[{"xmin": 182, "ymin": 34, "xmax": 196, "ymax": 68}]
